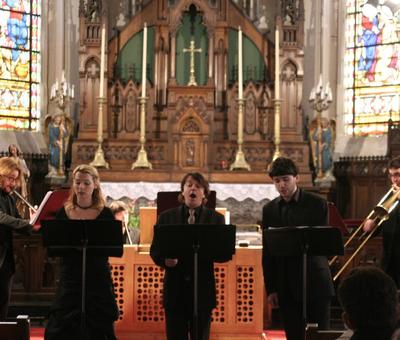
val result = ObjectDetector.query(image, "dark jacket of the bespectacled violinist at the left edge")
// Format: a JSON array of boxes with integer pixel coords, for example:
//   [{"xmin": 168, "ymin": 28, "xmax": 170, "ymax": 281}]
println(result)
[{"xmin": 0, "ymin": 189, "xmax": 32, "ymax": 273}]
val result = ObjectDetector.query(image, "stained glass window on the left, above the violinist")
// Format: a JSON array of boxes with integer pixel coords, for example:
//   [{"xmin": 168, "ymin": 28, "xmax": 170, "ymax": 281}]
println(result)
[{"xmin": 0, "ymin": 0, "xmax": 41, "ymax": 131}]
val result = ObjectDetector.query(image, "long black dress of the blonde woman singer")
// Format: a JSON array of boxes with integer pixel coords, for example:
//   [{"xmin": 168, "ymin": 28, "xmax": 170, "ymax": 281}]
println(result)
[{"xmin": 45, "ymin": 208, "xmax": 118, "ymax": 340}]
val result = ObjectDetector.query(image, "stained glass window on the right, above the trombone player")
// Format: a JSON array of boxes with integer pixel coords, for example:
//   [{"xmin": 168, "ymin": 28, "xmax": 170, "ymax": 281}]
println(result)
[{"xmin": 344, "ymin": 0, "xmax": 400, "ymax": 136}]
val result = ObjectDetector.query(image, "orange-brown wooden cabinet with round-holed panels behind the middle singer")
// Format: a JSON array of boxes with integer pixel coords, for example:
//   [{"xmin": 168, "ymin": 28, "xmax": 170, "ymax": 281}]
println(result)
[{"xmin": 110, "ymin": 246, "xmax": 264, "ymax": 340}]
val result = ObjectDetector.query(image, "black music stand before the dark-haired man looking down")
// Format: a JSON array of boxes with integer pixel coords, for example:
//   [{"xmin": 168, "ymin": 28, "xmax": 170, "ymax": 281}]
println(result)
[{"xmin": 264, "ymin": 227, "xmax": 344, "ymax": 340}]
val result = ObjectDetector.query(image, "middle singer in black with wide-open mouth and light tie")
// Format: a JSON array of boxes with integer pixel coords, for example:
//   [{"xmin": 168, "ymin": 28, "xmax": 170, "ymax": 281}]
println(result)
[{"xmin": 150, "ymin": 173, "xmax": 225, "ymax": 340}]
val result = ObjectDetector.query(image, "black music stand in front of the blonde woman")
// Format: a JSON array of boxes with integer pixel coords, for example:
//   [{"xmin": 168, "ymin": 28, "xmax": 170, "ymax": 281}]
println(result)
[{"xmin": 40, "ymin": 220, "xmax": 124, "ymax": 339}]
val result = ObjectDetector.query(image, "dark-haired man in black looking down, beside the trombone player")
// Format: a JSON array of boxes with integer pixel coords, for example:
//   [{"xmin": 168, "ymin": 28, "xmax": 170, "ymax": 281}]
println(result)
[{"xmin": 262, "ymin": 157, "xmax": 334, "ymax": 340}]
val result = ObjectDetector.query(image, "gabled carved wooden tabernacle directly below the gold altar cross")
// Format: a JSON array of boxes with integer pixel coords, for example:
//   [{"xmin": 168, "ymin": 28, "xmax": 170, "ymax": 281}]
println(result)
[{"xmin": 173, "ymin": 108, "xmax": 209, "ymax": 170}]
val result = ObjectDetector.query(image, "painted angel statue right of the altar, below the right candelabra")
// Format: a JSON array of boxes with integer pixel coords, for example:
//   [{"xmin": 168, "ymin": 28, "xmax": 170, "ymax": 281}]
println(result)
[{"xmin": 310, "ymin": 117, "xmax": 335, "ymax": 178}]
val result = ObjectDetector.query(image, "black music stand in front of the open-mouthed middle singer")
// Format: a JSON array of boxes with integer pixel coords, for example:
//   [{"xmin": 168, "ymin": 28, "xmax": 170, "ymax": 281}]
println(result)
[{"xmin": 153, "ymin": 224, "xmax": 236, "ymax": 340}]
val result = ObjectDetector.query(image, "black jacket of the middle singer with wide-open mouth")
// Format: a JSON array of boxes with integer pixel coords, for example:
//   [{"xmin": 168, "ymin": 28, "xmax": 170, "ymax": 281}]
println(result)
[{"xmin": 150, "ymin": 205, "xmax": 225, "ymax": 311}]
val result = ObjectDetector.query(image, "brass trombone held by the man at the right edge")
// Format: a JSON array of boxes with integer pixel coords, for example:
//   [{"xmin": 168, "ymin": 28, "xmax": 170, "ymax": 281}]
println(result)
[{"xmin": 329, "ymin": 188, "xmax": 400, "ymax": 281}]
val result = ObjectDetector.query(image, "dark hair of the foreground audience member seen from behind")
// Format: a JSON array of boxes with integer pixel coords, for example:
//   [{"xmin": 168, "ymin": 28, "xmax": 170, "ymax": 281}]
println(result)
[{"xmin": 338, "ymin": 266, "xmax": 398, "ymax": 329}]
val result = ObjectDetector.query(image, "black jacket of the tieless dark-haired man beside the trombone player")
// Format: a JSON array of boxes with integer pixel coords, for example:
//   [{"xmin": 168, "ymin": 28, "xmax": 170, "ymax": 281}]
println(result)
[{"xmin": 262, "ymin": 189, "xmax": 334, "ymax": 301}]
